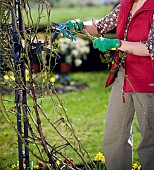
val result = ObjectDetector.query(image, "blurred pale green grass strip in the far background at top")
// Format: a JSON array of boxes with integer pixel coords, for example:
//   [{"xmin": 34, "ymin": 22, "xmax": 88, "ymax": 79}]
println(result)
[{"xmin": 26, "ymin": 6, "xmax": 112, "ymax": 25}]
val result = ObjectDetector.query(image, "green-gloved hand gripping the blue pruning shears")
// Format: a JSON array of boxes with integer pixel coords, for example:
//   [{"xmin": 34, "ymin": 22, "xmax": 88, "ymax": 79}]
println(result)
[{"xmin": 66, "ymin": 19, "xmax": 84, "ymax": 31}]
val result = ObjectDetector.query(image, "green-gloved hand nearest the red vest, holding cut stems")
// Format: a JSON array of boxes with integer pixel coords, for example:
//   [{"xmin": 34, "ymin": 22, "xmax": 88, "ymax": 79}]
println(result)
[{"xmin": 93, "ymin": 37, "xmax": 121, "ymax": 52}]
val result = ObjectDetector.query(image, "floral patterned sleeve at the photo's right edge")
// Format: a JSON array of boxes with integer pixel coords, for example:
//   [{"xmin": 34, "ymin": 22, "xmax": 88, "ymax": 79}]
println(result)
[{"xmin": 144, "ymin": 16, "xmax": 154, "ymax": 60}]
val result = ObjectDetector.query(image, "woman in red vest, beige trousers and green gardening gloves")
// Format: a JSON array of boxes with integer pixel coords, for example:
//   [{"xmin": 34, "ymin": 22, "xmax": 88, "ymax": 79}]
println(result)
[{"xmin": 67, "ymin": 0, "xmax": 154, "ymax": 170}]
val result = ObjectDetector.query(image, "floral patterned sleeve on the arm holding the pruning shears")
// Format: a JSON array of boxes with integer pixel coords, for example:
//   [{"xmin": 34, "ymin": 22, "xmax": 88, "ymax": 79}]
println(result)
[{"xmin": 93, "ymin": 4, "xmax": 120, "ymax": 36}]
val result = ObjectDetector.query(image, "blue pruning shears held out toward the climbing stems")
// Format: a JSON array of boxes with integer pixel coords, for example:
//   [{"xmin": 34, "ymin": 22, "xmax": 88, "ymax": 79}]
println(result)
[{"xmin": 51, "ymin": 22, "xmax": 76, "ymax": 42}]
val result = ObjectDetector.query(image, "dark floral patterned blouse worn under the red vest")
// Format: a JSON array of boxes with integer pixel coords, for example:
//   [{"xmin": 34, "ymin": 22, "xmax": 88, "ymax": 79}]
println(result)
[{"xmin": 93, "ymin": 4, "xmax": 154, "ymax": 60}]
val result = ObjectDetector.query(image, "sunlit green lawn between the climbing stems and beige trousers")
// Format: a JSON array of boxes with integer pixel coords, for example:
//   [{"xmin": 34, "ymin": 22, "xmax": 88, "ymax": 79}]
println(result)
[{"xmin": 0, "ymin": 72, "xmax": 140, "ymax": 169}]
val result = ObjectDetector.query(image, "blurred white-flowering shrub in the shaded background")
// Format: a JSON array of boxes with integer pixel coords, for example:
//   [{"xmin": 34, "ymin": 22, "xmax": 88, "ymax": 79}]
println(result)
[{"xmin": 58, "ymin": 38, "xmax": 90, "ymax": 66}]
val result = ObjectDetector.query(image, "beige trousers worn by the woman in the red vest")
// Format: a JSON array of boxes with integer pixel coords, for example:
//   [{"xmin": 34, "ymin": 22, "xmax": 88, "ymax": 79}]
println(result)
[{"xmin": 103, "ymin": 68, "xmax": 154, "ymax": 170}]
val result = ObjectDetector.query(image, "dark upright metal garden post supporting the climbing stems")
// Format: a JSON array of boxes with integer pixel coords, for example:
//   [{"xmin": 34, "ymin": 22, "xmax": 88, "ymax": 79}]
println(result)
[{"xmin": 12, "ymin": 0, "xmax": 29, "ymax": 170}]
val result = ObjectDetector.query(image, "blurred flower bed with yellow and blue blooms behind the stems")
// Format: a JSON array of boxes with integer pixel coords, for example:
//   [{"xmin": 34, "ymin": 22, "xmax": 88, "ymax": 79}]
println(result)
[{"xmin": 0, "ymin": 70, "xmax": 89, "ymax": 95}]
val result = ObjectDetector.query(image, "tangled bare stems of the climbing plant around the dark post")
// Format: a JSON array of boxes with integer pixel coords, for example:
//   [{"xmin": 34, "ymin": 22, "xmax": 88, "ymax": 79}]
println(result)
[{"xmin": 0, "ymin": 0, "xmax": 94, "ymax": 170}]
